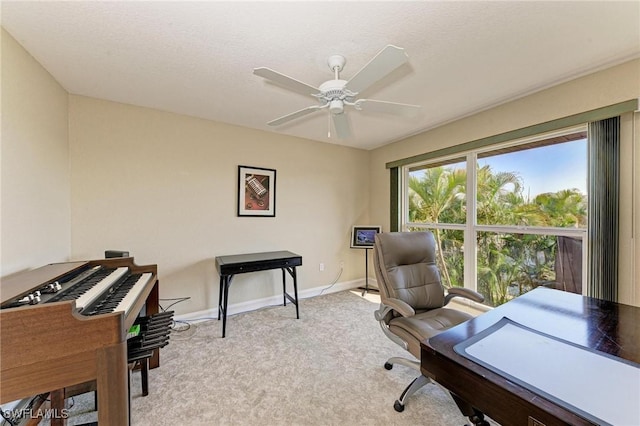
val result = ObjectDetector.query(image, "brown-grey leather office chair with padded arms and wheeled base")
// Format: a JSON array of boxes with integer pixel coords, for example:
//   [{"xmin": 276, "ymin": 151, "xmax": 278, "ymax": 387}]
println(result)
[{"xmin": 373, "ymin": 232, "xmax": 488, "ymax": 425}]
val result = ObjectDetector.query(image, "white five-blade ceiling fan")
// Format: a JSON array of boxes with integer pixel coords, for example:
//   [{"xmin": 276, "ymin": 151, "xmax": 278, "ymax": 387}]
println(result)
[{"xmin": 253, "ymin": 45, "xmax": 420, "ymax": 139}]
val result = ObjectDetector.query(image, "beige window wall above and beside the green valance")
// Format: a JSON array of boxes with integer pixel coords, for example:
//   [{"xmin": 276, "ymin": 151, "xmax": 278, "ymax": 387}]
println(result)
[{"xmin": 371, "ymin": 60, "xmax": 640, "ymax": 305}]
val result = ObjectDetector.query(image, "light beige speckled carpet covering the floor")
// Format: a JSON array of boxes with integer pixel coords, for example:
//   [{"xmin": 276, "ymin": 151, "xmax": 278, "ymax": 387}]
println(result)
[{"xmin": 62, "ymin": 291, "xmax": 478, "ymax": 426}]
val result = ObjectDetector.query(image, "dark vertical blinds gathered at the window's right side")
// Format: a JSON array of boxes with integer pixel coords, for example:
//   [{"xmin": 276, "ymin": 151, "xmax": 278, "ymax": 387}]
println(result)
[{"xmin": 587, "ymin": 117, "xmax": 620, "ymax": 302}]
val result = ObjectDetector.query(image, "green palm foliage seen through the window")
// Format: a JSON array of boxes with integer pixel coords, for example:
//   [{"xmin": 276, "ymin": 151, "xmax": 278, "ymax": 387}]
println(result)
[{"xmin": 409, "ymin": 165, "xmax": 587, "ymax": 306}]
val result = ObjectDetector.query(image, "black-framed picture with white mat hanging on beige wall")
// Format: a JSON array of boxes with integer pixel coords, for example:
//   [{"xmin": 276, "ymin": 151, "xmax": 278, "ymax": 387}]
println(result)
[{"xmin": 238, "ymin": 166, "xmax": 276, "ymax": 217}]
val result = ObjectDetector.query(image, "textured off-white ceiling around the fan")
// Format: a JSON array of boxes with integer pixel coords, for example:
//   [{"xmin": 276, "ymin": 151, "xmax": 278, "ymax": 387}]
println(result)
[{"xmin": 1, "ymin": 0, "xmax": 640, "ymax": 149}]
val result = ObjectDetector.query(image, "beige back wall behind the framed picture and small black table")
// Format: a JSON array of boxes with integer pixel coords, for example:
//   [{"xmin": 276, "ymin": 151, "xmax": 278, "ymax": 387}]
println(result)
[{"xmin": 69, "ymin": 96, "xmax": 369, "ymax": 313}]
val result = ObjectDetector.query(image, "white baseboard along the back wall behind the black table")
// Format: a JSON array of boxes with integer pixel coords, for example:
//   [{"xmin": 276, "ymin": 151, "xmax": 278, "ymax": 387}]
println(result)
[{"xmin": 174, "ymin": 278, "xmax": 377, "ymax": 322}]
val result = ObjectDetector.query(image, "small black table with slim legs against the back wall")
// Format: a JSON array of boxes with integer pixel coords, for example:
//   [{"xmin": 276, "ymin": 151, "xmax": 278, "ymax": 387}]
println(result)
[{"xmin": 216, "ymin": 251, "xmax": 302, "ymax": 337}]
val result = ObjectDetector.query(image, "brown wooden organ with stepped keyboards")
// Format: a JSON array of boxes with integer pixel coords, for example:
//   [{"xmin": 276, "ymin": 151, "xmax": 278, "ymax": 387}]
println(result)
[{"xmin": 0, "ymin": 258, "xmax": 159, "ymax": 425}]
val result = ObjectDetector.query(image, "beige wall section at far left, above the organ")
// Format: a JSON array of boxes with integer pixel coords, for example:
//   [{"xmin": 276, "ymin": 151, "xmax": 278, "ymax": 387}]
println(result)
[{"xmin": 0, "ymin": 30, "xmax": 71, "ymax": 276}]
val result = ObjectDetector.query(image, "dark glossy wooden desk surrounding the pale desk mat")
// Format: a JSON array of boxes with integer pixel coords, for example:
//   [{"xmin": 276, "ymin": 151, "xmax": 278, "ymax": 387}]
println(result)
[{"xmin": 421, "ymin": 288, "xmax": 640, "ymax": 426}]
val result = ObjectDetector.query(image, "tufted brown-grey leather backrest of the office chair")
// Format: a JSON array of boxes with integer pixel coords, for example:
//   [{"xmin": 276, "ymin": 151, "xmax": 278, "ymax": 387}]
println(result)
[{"xmin": 373, "ymin": 232, "xmax": 444, "ymax": 310}]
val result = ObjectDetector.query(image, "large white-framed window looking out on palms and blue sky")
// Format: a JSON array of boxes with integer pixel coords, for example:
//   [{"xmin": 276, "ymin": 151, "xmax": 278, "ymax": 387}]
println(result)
[{"xmin": 402, "ymin": 128, "xmax": 587, "ymax": 306}]
